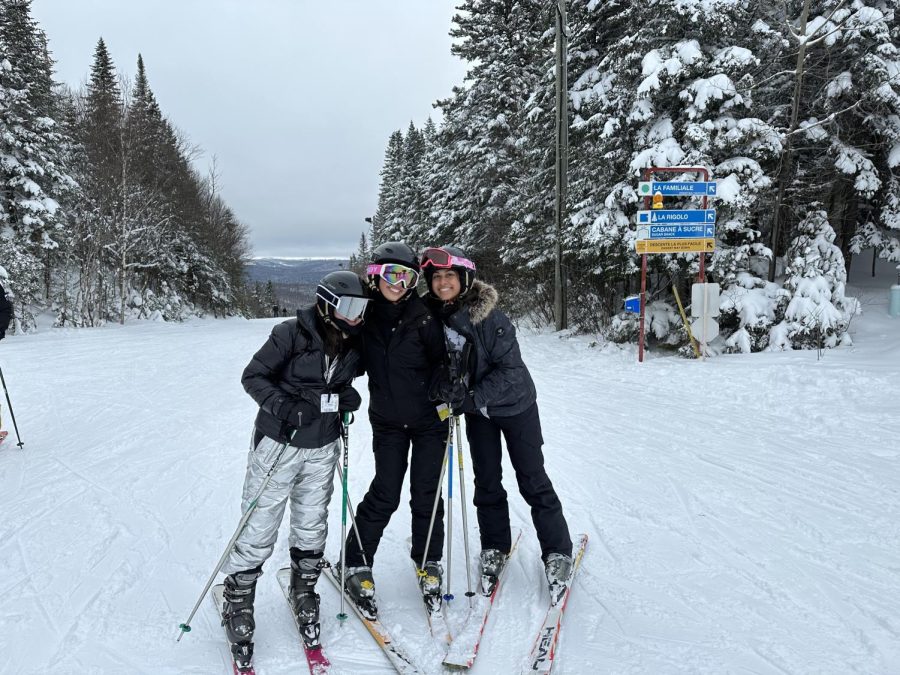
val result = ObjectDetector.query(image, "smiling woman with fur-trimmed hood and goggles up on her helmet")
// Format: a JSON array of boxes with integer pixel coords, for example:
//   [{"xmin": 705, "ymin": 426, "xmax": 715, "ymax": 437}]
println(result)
[{"xmin": 421, "ymin": 246, "xmax": 572, "ymax": 598}]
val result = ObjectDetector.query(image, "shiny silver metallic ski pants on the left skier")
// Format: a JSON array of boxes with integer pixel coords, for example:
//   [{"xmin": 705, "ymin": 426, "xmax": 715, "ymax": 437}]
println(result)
[{"xmin": 222, "ymin": 436, "xmax": 340, "ymax": 574}]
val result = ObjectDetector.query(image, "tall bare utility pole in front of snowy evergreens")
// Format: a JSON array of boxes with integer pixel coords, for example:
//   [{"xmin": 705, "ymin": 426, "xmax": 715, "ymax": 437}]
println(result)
[{"xmin": 553, "ymin": 0, "xmax": 569, "ymax": 330}]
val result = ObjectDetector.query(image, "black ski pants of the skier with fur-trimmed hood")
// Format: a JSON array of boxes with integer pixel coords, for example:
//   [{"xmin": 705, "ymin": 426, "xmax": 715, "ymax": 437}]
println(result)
[{"xmin": 466, "ymin": 403, "xmax": 572, "ymax": 559}]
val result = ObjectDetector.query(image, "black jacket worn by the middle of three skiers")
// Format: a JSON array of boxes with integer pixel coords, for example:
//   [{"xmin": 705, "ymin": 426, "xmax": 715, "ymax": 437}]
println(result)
[{"xmin": 362, "ymin": 291, "xmax": 447, "ymax": 427}]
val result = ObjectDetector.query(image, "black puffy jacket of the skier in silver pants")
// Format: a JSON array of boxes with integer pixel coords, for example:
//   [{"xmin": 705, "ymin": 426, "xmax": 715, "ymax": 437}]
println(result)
[{"xmin": 241, "ymin": 306, "xmax": 360, "ymax": 448}]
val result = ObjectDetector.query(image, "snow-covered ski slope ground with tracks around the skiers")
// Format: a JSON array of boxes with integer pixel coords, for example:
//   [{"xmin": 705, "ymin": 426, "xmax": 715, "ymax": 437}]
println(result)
[{"xmin": 0, "ymin": 264, "xmax": 900, "ymax": 675}]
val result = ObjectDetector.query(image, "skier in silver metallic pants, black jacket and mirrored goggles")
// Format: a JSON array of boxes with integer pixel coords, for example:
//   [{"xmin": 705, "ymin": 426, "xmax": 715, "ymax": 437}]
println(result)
[{"xmin": 222, "ymin": 271, "xmax": 369, "ymax": 667}]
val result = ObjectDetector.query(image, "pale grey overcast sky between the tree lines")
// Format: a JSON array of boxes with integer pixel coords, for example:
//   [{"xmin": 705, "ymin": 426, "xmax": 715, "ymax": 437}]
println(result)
[{"xmin": 32, "ymin": 0, "xmax": 465, "ymax": 256}]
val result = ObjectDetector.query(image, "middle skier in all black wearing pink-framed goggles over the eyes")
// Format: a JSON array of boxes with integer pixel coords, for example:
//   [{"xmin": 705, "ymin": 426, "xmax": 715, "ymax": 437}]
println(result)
[{"xmin": 346, "ymin": 242, "xmax": 448, "ymax": 617}]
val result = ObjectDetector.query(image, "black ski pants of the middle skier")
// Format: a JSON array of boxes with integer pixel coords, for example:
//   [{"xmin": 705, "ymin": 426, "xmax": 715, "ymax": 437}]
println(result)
[{"xmin": 346, "ymin": 419, "xmax": 448, "ymax": 567}]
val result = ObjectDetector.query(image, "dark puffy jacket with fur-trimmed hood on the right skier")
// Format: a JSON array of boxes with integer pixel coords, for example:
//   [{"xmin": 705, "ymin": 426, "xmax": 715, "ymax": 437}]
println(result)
[{"xmin": 428, "ymin": 279, "xmax": 537, "ymax": 417}]
